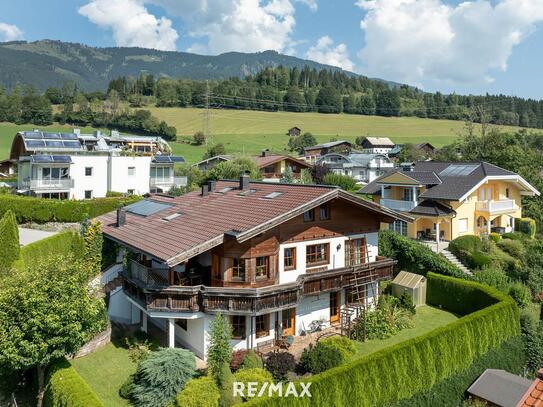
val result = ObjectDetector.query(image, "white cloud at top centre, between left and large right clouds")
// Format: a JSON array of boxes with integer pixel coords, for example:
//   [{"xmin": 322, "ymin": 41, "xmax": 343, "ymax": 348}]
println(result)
[{"xmin": 150, "ymin": 0, "xmax": 296, "ymax": 54}]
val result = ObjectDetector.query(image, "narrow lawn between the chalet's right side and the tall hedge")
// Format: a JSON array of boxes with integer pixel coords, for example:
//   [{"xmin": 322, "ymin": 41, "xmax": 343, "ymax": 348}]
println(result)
[{"xmin": 355, "ymin": 305, "xmax": 458, "ymax": 357}]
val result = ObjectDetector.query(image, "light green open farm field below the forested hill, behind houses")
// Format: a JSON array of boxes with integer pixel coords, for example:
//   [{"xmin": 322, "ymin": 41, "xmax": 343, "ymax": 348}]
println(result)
[{"xmin": 0, "ymin": 107, "xmax": 538, "ymax": 163}]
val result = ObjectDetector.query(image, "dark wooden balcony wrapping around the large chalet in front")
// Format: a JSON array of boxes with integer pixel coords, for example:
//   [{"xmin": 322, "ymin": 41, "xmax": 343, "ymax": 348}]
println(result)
[{"xmin": 123, "ymin": 257, "xmax": 396, "ymax": 315}]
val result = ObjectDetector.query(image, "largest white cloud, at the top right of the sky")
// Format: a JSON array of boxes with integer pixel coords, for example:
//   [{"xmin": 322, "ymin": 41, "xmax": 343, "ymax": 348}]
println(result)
[{"xmin": 356, "ymin": 0, "xmax": 543, "ymax": 85}]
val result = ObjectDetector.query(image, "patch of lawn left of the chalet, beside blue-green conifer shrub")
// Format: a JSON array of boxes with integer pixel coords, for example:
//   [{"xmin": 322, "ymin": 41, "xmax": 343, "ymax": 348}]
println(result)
[{"xmin": 70, "ymin": 343, "xmax": 136, "ymax": 407}]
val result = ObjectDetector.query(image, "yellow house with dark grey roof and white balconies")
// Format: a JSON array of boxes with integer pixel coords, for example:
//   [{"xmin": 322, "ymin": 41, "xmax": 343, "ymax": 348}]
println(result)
[{"xmin": 360, "ymin": 161, "xmax": 539, "ymax": 242}]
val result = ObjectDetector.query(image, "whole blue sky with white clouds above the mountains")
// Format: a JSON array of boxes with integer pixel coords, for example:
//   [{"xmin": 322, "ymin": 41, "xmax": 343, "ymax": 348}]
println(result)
[{"xmin": 0, "ymin": 0, "xmax": 543, "ymax": 99}]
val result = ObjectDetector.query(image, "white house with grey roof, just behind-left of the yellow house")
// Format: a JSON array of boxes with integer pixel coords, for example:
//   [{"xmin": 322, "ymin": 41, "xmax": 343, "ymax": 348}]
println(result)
[{"xmin": 317, "ymin": 152, "xmax": 394, "ymax": 184}]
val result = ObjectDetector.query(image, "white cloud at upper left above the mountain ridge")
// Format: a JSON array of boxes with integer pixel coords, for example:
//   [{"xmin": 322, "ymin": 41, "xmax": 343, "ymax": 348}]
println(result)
[{"xmin": 79, "ymin": 0, "xmax": 179, "ymax": 51}]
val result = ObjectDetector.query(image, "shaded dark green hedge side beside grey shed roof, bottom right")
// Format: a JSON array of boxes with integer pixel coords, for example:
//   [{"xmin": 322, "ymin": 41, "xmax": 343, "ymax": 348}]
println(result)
[{"xmin": 395, "ymin": 337, "xmax": 526, "ymax": 407}]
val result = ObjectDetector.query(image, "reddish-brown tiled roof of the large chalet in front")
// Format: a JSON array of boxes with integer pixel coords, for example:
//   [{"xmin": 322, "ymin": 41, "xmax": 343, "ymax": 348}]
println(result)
[{"xmin": 98, "ymin": 181, "xmax": 410, "ymax": 265}]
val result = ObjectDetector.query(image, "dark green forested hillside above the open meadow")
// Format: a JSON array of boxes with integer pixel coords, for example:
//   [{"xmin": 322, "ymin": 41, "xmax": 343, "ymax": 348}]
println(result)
[{"xmin": 108, "ymin": 66, "xmax": 543, "ymax": 128}]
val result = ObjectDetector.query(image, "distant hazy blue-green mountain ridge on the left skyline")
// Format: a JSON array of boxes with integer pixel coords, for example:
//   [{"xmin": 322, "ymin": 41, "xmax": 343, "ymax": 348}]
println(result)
[{"xmin": 0, "ymin": 40, "xmax": 376, "ymax": 91}]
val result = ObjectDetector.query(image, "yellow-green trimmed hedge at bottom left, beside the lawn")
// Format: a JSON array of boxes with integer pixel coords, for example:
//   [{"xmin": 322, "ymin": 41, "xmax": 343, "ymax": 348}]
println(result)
[{"xmin": 44, "ymin": 359, "xmax": 104, "ymax": 407}]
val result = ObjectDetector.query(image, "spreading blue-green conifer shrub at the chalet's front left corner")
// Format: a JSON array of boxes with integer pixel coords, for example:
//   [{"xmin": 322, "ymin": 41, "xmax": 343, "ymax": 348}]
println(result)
[{"xmin": 131, "ymin": 348, "xmax": 196, "ymax": 407}]
